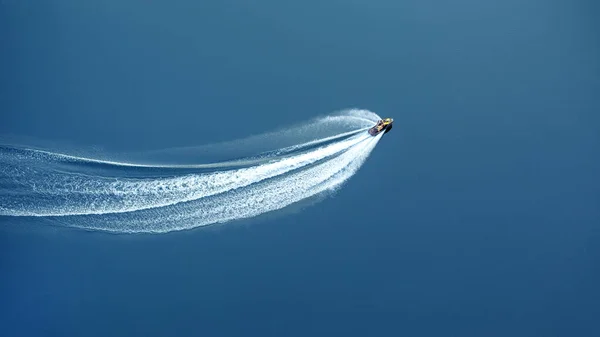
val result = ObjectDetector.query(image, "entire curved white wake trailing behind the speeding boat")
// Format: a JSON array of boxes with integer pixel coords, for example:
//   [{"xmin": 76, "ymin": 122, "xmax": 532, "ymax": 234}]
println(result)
[{"xmin": 0, "ymin": 110, "xmax": 381, "ymax": 233}]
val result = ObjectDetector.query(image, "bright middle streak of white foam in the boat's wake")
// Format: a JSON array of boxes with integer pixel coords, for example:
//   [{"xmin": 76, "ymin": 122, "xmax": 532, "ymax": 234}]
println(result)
[{"xmin": 0, "ymin": 133, "xmax": 369, "ymax": 216}]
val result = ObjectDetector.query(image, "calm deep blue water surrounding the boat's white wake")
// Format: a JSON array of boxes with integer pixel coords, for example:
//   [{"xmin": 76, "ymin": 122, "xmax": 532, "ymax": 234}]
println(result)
[{"xmin": 0, "ymin": 0, "xmax": 600, "ymax": 336}]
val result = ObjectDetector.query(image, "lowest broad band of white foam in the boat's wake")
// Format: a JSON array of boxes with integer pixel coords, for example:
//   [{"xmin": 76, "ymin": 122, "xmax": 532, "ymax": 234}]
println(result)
[{"xmin": 65, "ymin": 135, "xmax": 382, "ymax": 233}]
